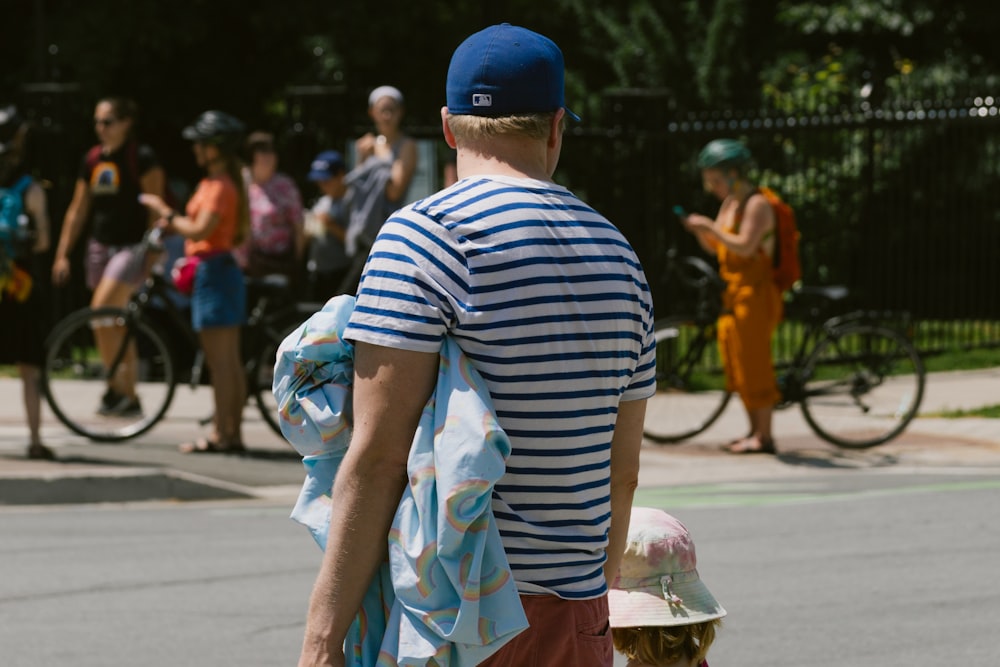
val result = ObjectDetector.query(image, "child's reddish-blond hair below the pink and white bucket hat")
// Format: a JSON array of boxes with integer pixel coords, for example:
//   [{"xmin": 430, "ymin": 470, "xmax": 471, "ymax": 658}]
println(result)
[{"xmin": 611, "ymin": 619, "xmax": 722, "ymax": 667}]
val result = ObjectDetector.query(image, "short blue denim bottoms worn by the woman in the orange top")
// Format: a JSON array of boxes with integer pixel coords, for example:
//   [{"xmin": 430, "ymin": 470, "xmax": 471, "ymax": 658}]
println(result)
[{"xmin": 191, "ymin": 252, "xmax": 247, "ymax": 331}]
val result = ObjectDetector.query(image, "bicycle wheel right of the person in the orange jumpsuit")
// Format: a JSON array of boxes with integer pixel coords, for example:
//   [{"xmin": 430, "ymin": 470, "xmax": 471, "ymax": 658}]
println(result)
[{"xmin": 801, "ymin": 324, "xmax": 924, "ymax": 449}]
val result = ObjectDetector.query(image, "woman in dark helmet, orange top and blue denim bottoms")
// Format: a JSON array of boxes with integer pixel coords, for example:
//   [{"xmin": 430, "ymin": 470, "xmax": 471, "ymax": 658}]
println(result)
[{"xmin": 141, "ymin": 111, "xmax": 250, "ymax": 453}]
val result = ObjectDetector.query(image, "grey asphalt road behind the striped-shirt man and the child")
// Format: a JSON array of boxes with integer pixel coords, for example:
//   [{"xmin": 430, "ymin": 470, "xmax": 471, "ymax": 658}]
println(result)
[{"xmin": 0, "ymin": 466, "xmax": 1000, "ymax": 667}]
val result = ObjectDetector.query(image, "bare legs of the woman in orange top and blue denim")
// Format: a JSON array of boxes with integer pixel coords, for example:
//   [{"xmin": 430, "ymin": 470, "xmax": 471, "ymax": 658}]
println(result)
[{"xmin": 199, "ymin": 327, "xmax": 246, "ymax": 450}]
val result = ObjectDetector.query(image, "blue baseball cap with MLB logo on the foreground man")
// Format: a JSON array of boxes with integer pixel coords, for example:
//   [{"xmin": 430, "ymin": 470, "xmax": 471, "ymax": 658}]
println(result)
[{"xmin": 446, "ymin": 23, "xmax": 580, "ymax": 120}]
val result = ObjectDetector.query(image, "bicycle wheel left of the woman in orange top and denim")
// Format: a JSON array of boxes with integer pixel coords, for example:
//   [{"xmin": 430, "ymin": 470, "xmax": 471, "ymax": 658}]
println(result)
[{"xmin": 42, "ymin": 308, "xmax": 175, "ymax": 442}]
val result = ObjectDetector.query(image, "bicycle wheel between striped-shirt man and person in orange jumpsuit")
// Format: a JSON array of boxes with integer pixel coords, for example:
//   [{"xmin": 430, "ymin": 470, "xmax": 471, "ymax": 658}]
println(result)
[{"xmin": 643, "ymin": 317, "xmax": 730, "ymax": 443}]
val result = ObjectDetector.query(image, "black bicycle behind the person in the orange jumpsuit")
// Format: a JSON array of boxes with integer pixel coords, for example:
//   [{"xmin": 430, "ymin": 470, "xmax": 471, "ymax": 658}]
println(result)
[{"xmin": 644, "ymin": 248, "xmax": 925, "ymax": 449}]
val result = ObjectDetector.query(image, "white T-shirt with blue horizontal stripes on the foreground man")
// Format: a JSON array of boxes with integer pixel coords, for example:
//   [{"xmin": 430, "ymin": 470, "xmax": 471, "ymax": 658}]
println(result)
[{"xmin": 344, "ymin": 176, "xmax": 655, "ymax": 599}]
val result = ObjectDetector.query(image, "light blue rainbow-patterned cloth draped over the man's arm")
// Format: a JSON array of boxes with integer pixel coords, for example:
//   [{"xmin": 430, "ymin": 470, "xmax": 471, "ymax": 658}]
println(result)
[{"xmin": 274, "ymin": 296, "xmax": 528, "ymax": 667}]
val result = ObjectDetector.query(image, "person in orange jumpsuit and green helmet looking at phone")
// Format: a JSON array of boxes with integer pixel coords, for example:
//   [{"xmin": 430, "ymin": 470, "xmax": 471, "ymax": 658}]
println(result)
[{"xmin": 683, "ymin": 139, "xmax": 783, "ymax": 454}]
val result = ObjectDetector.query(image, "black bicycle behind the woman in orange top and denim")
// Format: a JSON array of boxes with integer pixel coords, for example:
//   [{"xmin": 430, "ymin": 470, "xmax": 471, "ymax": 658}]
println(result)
[{"xmin": 42, "ymin": 231, "xmax": 320, "ymax": 442}]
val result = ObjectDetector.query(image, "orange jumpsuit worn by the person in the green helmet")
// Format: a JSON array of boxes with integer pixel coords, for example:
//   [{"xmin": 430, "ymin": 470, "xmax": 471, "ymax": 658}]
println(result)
[{"xmin": 716, "ymin": 216, "xmax": 784, "ymax": 411}]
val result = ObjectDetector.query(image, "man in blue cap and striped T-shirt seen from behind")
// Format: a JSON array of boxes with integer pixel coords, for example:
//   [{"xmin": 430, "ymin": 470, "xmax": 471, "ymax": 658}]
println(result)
[{"xmin": 299, "ymin": 24, "xmax": 655, "ymax": 667}]
